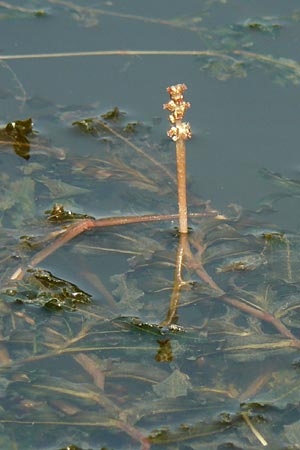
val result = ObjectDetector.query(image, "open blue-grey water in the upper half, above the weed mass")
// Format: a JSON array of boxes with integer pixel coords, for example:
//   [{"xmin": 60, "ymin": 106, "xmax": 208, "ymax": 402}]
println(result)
[{"xmin": 1, "ymin": 0, "xmax": 299, "ymax": 221}]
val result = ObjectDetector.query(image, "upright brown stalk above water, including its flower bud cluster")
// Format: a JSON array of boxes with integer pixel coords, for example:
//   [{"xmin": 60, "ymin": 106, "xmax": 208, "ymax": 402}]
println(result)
[{"xmin": 164, "ymin": 84, "xmax": 192, "ymax": 233}]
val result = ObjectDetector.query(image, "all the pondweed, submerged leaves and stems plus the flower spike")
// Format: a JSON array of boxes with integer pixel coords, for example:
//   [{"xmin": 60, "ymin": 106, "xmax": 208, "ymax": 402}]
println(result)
[{"xmin": 0, "ymin": 0, "xmax": 300, "ymax": 450}]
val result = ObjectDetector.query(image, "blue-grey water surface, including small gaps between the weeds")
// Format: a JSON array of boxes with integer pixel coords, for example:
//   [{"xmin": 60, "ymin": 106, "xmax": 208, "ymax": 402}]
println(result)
[{"xmin": 0, "ymin": 0, "xmax": 300, "ymax": 450}]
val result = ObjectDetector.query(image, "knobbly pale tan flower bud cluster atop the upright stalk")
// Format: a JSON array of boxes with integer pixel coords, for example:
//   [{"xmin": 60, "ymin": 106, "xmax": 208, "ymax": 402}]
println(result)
[{"xmin": 164, "ymin": 84, "xmax": 192, "ymax": 142}]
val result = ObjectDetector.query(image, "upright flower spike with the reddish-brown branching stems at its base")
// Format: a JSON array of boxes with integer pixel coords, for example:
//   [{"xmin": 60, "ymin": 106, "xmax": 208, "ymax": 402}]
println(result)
[{"xmin": 10, "ymin": 84, "xmax": 300, "ymax": 348}]
